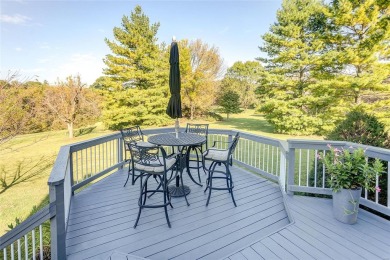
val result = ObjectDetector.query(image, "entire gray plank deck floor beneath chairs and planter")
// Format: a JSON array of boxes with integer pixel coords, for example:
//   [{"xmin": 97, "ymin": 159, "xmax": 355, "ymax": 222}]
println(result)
[{"xmin": 66, "ymin": 167, "xmax": 390, "ymax": 260}]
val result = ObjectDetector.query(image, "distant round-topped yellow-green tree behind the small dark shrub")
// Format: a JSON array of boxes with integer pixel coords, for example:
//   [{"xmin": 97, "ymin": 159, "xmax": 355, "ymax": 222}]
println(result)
[{"xmin": 221, "ymin": 61, "xmax": 263, "ymax": 109}]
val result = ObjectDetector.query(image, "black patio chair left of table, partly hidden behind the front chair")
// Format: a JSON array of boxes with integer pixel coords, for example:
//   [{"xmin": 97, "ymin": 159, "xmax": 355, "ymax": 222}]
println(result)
[{"xmin": 120, "ymin": 125, "xmax": 155, "ymax": 187}]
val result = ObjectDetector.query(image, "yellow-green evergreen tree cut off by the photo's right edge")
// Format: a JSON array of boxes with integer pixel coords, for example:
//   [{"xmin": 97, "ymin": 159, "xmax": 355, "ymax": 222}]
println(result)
[{"xmin": 324, "ymin": 0, "xmax": 390, "ymax": 118}]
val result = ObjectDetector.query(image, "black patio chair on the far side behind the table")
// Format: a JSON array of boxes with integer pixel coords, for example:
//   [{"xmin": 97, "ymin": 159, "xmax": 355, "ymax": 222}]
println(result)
[{"xmin": 186, "ymin": 123, "xmax": 209, "ymax": 183}]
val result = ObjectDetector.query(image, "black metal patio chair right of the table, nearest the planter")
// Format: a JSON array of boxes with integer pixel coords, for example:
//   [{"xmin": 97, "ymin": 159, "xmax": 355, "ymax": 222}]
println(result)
[{"xmin": 202, "ymin": 133, "xmax": 240, "ymax": 207}]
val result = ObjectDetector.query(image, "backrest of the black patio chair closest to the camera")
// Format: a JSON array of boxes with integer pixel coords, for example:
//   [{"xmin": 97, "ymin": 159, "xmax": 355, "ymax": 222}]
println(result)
[{"xmin": 127, "ymin": 142, "xmax": 167, "ymax": 172}]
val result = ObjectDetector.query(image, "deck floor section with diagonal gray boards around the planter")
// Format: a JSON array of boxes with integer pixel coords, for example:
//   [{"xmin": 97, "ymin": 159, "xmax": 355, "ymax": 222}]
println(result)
[{"xmin": 229, "ymin": 196, "xmax": 390, "ymax": 259}]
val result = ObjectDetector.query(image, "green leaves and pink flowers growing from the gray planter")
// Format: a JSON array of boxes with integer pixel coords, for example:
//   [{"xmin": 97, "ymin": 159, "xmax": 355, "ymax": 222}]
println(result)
[{"xmin": 319, "ymin": 145, "xmax": 384, "ymax": 192}]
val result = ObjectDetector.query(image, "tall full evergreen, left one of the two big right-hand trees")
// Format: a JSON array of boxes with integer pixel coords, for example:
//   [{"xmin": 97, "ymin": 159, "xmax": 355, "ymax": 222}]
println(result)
[{"xmin": 258, "ymin": 0, "xmax": 344, "ymax": 134}]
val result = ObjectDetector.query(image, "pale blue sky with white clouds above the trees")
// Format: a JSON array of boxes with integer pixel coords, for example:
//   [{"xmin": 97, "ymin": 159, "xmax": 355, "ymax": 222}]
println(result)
[{"xmin": 0, "ymin": 0, "xmax": 281, "ymax": 85}]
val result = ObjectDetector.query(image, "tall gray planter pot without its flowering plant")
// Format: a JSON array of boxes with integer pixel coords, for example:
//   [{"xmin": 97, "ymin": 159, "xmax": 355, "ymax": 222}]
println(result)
[{"xmin": 332, "ymin": 188, "xmax": 362, "ymax": 224}]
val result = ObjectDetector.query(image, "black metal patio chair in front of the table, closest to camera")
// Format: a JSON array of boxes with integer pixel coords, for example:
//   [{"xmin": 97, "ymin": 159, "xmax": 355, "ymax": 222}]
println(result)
[{"xmin": 129, "ymin": 143, "xmax": 177, "ymax": 228}]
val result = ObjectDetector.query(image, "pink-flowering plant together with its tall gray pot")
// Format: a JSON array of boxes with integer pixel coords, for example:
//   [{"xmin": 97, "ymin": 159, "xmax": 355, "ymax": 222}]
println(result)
[{"xmin": 319, "ymin": 145, "xmax": 384, "ymax": 224}]
